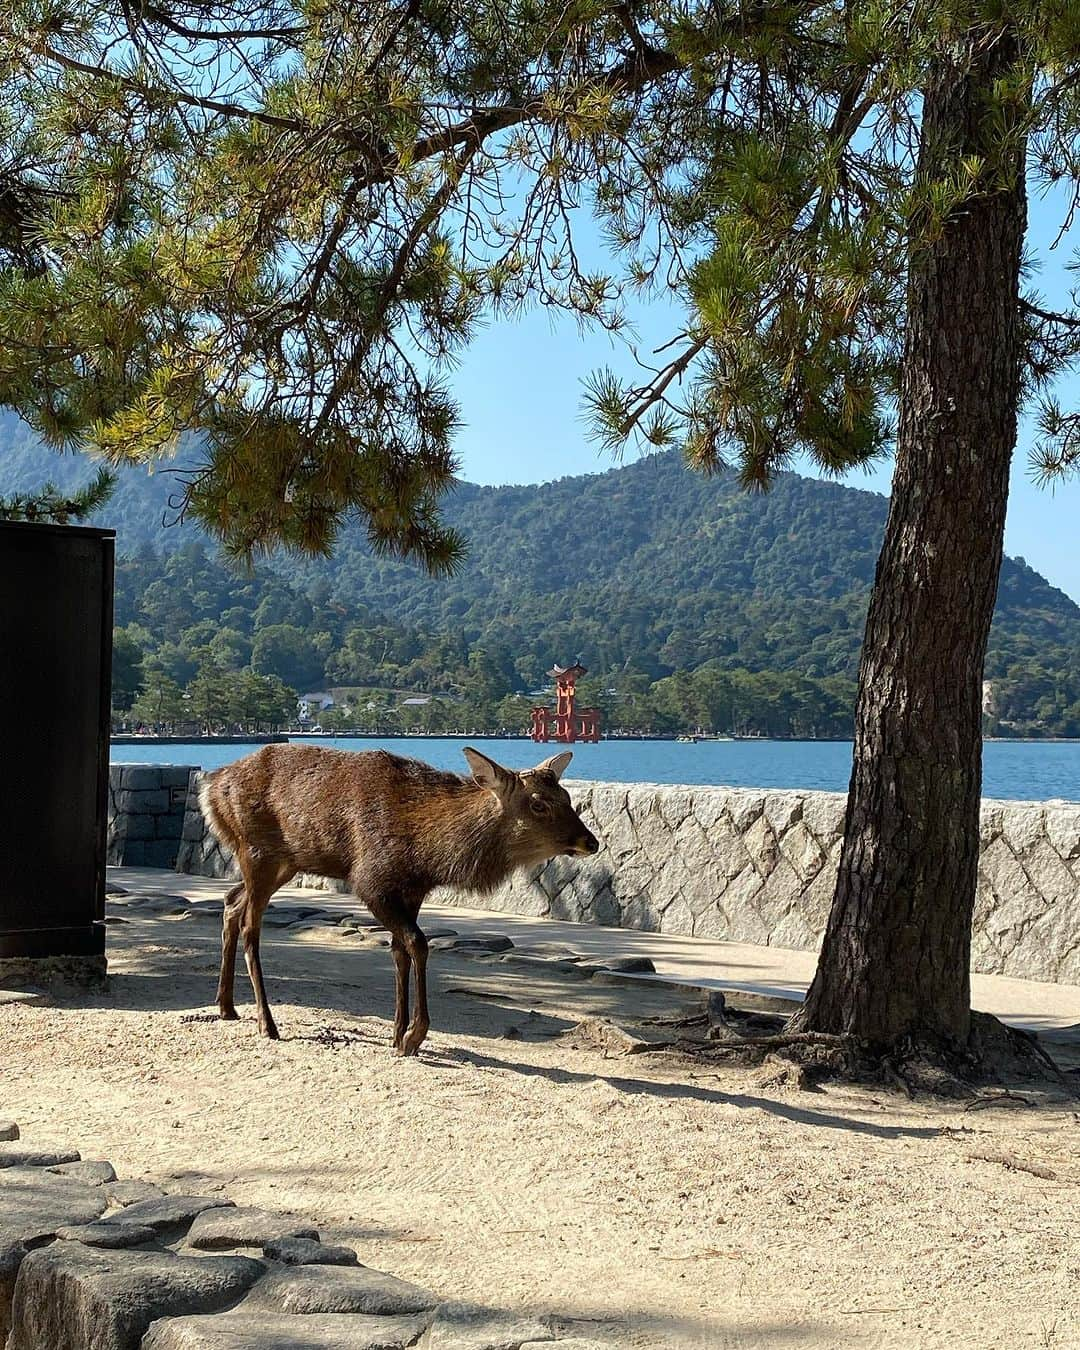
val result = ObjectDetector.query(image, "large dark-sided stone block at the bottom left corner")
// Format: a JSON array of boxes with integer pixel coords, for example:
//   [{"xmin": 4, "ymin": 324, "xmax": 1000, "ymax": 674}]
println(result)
[{"xmin": 7, "ymin": 1242, "xmax": 265, "ymax": 1350}]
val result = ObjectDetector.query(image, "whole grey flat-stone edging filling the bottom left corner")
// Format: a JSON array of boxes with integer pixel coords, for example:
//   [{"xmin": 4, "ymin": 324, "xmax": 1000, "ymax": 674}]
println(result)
[{"xmin": 0, "ymin": 1121, "xmax": 610, "ymax": 1350}]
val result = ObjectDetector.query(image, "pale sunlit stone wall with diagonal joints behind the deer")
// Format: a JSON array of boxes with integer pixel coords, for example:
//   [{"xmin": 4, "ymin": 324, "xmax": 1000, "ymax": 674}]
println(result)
[{"xmin": 155, "ymin": 779, "xmax": 1080, "ymax": 983}]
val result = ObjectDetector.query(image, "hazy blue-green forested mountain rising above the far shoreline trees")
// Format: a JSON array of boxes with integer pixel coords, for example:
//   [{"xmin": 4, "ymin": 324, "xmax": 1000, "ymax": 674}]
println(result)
[{"xmin": 0, "ymin": 416, "xmax": 1080, "ymax": 734}]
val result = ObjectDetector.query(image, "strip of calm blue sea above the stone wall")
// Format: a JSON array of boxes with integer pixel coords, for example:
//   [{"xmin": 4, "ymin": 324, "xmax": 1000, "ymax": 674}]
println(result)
[{"xmin": 112, "ymin": 736, "xmax": 1080, "ymax": 802}]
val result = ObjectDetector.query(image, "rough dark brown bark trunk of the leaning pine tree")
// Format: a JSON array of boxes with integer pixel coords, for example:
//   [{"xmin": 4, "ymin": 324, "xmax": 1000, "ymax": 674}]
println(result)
[{"xmin": 798, "ymin": 32, "xmax": 1026, "ymax": 1050}]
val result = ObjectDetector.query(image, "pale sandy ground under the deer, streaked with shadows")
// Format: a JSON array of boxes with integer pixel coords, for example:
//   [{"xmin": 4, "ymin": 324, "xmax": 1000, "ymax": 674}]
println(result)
[{"xmin": 0, "ymin": 899, "xmax": 1080, "ymax": 1350}]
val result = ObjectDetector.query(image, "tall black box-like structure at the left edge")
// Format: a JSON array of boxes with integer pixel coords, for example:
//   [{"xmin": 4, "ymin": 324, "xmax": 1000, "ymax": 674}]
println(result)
[{"xmin": 0, "ymin": 521, "xmax": 115, "ymax": 959}]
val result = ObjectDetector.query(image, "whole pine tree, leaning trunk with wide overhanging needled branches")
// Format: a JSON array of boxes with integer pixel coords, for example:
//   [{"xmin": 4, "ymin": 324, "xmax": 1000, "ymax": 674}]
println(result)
[{"xmin": 0, "ymin": 0, "xmax": 1080, "ymax": 1074}]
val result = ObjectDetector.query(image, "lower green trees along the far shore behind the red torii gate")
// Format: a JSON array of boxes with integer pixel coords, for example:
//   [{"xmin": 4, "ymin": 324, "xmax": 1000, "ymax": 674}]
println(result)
[{"xmin": 113, "ymin": 541, "xmax": 1080, "ymax": 737}]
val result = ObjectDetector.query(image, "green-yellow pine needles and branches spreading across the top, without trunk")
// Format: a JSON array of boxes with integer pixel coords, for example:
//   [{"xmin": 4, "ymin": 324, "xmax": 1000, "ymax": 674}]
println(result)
[{"xmin": 0, "ymin": 0, "xmax": 1080, "ymax": 558}]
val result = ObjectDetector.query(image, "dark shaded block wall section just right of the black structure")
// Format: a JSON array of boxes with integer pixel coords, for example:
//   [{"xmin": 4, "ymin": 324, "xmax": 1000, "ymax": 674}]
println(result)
[{"xmin": 105, "ymin": 764, "xmax": 198, "ymax": 867}]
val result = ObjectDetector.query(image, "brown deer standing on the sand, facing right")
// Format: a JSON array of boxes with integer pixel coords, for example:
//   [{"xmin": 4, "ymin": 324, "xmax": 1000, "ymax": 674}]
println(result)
[{"xmin": 200, "ymin": 745, "xmax": 599, "ymax": 1054}]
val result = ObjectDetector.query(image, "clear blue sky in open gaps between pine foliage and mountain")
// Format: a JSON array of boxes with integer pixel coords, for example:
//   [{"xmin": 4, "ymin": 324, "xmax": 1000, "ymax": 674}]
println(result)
[{"xmin": 451, "ymin": 201, "xmax": 1080, "ymax": 601}]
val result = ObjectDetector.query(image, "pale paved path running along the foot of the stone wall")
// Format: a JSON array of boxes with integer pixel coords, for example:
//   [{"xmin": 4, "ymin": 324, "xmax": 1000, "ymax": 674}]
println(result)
[{"xmin": 108, "ymin": 867, "xmax": 1080, "ymax": 1042}]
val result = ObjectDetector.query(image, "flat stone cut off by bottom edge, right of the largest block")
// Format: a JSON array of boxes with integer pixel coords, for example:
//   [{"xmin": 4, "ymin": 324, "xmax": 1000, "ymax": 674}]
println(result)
[{"xmin": 142, "ymin": 1312, "xmax": 427, "ymax": 1350}]
